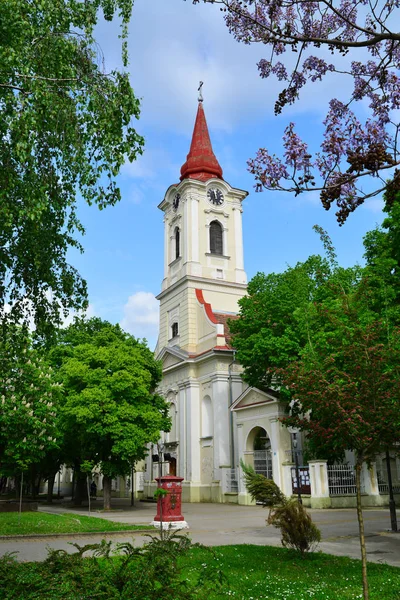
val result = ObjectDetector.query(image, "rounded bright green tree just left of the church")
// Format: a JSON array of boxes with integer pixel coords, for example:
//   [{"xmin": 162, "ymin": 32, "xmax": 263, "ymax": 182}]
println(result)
[{"xmin": 50, "ymin": 318, "xmax": 170, "ymax": 509}]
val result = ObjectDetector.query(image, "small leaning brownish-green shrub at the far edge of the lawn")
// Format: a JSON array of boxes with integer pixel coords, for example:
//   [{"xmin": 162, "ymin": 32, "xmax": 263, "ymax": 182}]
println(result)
[{"xmin": 240, "ymin": 461, "xmax": 321, "ymax": 556}]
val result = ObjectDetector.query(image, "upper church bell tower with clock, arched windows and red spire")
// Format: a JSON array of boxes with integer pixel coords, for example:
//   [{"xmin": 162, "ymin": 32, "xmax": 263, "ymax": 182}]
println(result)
[{"xmin": 157, "ymin": 95, "xmax": 247, "ymax": 354}]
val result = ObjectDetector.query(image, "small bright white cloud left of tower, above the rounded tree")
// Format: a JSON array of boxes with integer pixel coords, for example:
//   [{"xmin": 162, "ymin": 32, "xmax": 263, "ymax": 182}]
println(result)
[{"xmin": 120, "ymin": 291, "xmax": 158, "ymax": 348}]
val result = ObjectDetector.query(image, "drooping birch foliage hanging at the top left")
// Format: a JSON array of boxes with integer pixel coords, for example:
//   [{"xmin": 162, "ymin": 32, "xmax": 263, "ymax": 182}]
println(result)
[{"xmin": 0, "ymin": 0, "xmax": 143, "ymax": 330}]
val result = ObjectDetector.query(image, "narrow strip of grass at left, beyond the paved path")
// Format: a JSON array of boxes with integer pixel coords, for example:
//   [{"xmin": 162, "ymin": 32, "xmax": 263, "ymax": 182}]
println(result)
[{"xmin": 0, "ymin": 512, "xmax": 150, "ymax": 535}]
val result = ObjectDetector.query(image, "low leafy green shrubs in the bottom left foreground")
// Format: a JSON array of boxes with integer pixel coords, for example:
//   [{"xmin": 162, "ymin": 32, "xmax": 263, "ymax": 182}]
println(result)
[{"xmin": 0, "ymin": 530, "xmax": 223, "ymax": 600}]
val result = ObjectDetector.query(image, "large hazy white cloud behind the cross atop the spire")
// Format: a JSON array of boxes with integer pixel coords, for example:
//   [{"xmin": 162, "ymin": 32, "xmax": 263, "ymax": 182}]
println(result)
[{"xmin": 123, "ymin": 0, "xmax": 274, "ymax": 134}]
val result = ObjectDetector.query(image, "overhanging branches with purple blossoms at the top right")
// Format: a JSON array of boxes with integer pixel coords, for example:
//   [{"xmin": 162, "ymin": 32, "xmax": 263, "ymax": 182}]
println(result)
[{"xmin": 193, "ymin": 0, "xmax": 400, "ymax": 224}]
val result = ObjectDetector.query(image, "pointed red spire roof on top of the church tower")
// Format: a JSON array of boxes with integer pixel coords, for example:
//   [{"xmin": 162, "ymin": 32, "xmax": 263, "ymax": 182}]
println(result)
[{"xmin": 181, "ymin": 102, "xmax": 222, "ymax": 181}]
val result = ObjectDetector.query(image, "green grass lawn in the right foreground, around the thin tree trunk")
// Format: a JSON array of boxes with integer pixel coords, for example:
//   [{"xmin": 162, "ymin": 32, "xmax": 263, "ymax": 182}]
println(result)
[{"xmin": 184, "ymin": 545, "xmax": 400, "ymax": 600}]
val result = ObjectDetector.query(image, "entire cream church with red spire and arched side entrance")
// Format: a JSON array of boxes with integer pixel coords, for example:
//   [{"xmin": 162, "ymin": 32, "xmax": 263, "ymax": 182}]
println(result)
[{"xmin": 143, "ymin": 95, "xmax": 292, "ymax": 504}]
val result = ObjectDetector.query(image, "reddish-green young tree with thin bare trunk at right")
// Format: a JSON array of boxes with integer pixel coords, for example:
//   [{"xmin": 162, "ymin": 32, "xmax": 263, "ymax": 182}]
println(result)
[{"xmin": 282, "ymin": 280, "xmax": 400, "ymax": 600}]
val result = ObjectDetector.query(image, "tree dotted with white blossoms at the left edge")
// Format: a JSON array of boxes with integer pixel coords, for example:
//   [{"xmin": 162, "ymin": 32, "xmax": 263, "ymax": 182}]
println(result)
[{"xmin": 0, "ymin": 328, "xmax": 61, "ymax": 476}]
